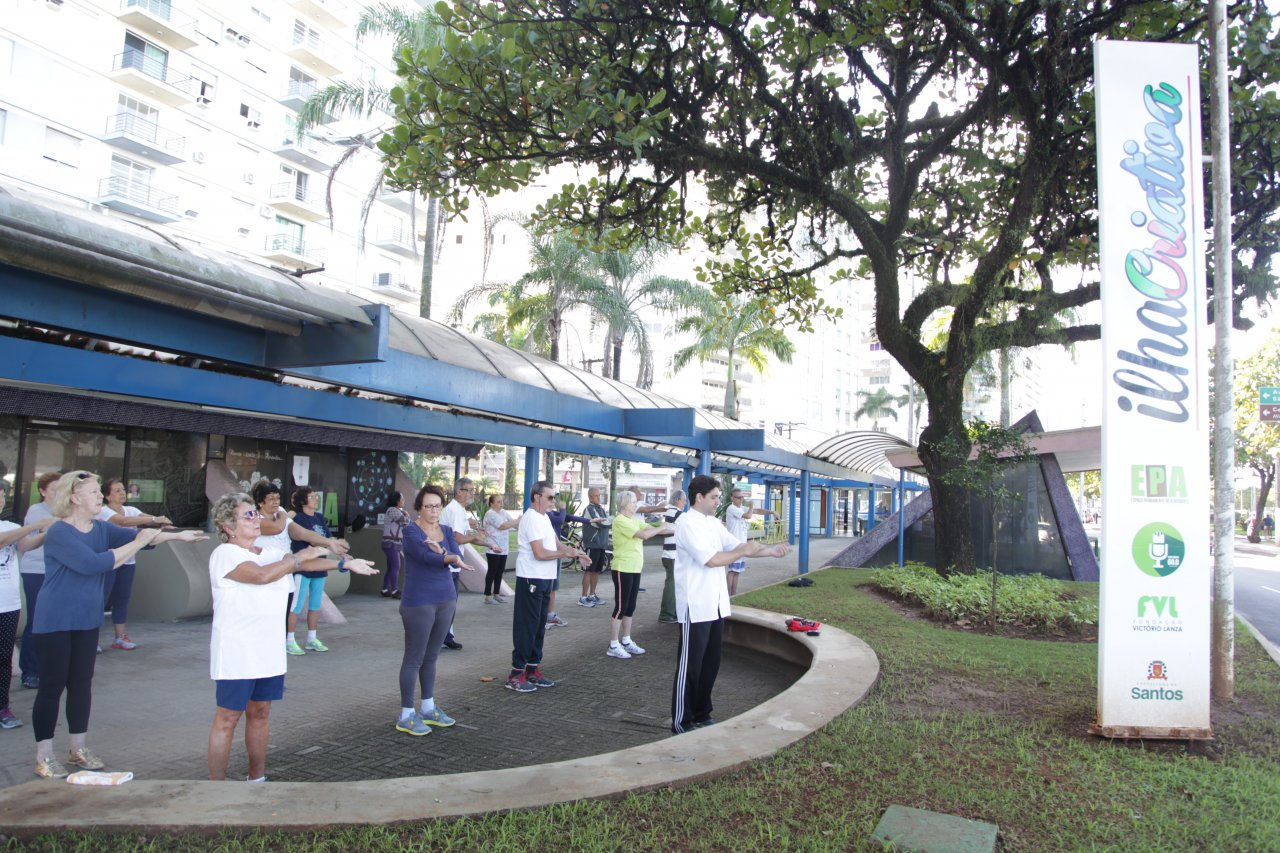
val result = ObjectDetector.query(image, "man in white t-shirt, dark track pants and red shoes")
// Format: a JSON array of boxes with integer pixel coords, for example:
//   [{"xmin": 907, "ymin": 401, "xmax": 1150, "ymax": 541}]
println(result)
[{"xmin": 507, "ymin": 480, "xmax": 591, "ymax": 693}]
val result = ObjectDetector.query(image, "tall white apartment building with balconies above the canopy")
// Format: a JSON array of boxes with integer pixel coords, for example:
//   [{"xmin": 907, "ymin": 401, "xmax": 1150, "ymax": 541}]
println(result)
[{"xmin": 0, "ymin": 0, "xmax": 424, "ymax": 313}]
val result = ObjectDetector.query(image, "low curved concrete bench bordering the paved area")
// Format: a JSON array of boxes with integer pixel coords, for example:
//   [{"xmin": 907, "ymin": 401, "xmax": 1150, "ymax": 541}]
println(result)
[{"xmin": 0, "ymin": 607, "xmax": 879, "ymax": 835}]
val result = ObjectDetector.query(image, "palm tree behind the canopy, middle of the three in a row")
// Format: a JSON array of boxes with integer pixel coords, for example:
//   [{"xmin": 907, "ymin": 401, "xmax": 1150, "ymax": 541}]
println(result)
[{"xmin": 591, "ymin": 243, "xmax": 694, "ymax": 388}]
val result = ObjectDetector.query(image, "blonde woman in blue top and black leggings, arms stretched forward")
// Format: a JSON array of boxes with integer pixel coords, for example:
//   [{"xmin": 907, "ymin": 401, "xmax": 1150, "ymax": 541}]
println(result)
[{"xmin": 31, "ymin": 471, "xmax": 207, "ymax": 779}]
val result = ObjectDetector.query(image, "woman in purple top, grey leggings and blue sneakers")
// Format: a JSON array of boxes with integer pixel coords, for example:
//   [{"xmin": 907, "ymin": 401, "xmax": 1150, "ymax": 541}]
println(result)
[{"xmin": 396, "ymin": 485, "xmax": 462, "ymax": 738}]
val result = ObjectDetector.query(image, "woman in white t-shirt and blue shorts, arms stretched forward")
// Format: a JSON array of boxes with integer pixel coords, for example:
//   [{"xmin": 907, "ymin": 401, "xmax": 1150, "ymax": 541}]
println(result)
[{"xmin": 209, "ymin": 493, "xmax": 378, "ymax": 781}]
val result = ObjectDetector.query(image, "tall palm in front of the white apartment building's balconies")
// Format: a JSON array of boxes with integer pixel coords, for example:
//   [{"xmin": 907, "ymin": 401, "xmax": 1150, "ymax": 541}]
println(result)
[{"xmin": 296, "ymin": 3, "xmax": 444, "ymax": 318}]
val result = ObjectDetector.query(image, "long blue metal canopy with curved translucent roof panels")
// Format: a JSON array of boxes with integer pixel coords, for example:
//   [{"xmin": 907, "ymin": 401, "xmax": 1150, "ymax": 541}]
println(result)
[{"xmin": 0, "ymin": 188, "xmax": 891, "ymax": 485}]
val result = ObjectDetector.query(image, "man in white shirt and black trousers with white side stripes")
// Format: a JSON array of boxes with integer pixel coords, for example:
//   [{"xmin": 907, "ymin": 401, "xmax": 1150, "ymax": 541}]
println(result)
[{"xmin": 671, "ymin": 474, "xmax": 787, "ymax": 734}]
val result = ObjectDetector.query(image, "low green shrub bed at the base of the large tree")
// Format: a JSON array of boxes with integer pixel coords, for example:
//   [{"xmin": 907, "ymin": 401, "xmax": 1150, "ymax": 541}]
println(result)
[{"xmin": 872, "ymin": 562, "xmax": 1098, "ymax": 633}]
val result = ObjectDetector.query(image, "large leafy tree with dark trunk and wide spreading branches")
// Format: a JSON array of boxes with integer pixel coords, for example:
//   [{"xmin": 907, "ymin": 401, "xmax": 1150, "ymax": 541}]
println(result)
[{"xmin": 380, "ymin": 0, "xmax": 1280, "ymax": 570}]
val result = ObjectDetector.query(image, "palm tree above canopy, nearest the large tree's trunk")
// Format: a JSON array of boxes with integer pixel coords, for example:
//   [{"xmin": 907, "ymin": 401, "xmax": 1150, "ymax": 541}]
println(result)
[{"xmin": 671, "ymin": 288, "xmax": 796, "ymax": 419}]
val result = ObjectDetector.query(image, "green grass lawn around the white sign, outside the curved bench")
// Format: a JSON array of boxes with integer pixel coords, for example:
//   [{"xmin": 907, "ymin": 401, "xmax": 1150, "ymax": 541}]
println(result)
[{"xmin": 10, "ymin": 569, "xmax": 1280, "ymax": 853}]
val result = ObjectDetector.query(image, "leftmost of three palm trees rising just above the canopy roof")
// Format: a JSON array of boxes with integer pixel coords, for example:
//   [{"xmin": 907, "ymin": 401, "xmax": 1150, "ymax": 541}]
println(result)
[{"xmin": 448, "ymin": 225, "xmax": 608, "ymax": 361}]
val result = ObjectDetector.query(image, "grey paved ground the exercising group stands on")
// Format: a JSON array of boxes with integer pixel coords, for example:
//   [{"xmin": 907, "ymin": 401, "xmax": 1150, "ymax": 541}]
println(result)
[{"xmin": 0, "ymin": 539, "xmax": 847, "ymax": 786}]
